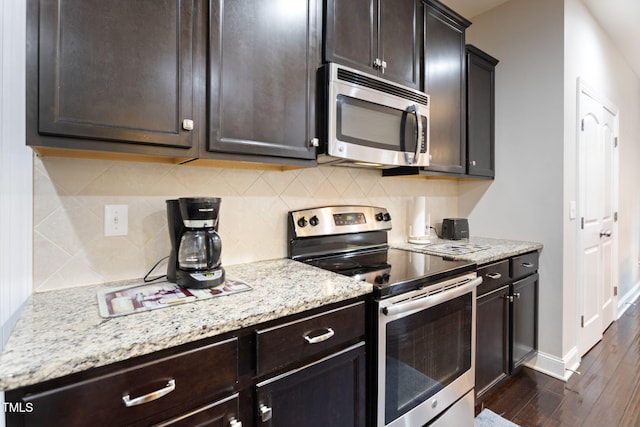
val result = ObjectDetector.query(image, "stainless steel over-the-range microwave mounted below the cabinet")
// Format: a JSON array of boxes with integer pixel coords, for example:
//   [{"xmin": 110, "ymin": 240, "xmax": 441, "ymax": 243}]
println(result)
[{"xmin": 318, "ymin": 63, "xmax": 429, "ymax": 168}]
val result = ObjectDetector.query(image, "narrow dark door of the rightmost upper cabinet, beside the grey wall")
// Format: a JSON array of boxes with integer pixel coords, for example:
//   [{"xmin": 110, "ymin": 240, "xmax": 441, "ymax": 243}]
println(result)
[{"xmin": 467, "ymin": 46, "xmax": 498, "ymax": 178}]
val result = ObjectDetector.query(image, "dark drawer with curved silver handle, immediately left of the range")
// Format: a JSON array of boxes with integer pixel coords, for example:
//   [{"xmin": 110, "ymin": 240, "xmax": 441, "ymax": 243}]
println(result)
[{"xmin": 256, "ymin": 302, "xmax": 365, "ymax": 376}]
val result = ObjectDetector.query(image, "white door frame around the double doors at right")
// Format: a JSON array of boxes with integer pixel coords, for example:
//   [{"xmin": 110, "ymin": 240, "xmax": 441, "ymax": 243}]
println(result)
[{"xmin": 574, "ymin": 77, "xmax": 620, "ymax": 359}]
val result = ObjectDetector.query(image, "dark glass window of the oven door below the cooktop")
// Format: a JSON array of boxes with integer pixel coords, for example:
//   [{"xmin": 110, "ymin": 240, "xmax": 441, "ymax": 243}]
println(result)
[{"xmin": 385, "ymin": 293, "xmax": 473, "ymax": 423}]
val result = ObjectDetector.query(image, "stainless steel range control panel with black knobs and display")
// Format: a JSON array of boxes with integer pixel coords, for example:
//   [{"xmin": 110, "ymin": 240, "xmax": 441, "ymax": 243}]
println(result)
[{"xmin": 289, "ymin": 206, "xmax": 391, "ymax": 237}]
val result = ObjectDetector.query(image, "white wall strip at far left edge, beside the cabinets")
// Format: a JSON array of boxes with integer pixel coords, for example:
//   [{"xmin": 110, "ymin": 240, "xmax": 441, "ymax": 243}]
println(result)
[{"xmin": 0, "ymin": 1, "xmax": 32, "ymax": 426}]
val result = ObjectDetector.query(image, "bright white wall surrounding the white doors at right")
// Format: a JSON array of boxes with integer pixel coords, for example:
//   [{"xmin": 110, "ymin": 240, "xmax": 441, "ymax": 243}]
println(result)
[{"xmin": 564, "ymin": 0, "xmax": 640, "ymax": 353}]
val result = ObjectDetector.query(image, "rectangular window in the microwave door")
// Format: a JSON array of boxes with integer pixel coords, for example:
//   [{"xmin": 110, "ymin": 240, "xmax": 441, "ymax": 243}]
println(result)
[{"xmin": 336, "ymin": 95, "xmax": 416, "ymax": 153}]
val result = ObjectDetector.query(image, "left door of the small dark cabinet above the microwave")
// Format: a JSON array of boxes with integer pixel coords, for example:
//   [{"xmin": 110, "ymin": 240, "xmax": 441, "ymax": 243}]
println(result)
[{"xmin": 324, "ymin": 0, "xmax": 378, "ymax": 73}]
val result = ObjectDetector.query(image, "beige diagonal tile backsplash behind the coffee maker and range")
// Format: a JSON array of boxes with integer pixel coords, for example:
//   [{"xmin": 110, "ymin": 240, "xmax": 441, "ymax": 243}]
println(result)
[{"xmin": 34, "ymin": 156, "xmax": 458, "ymax": 291}]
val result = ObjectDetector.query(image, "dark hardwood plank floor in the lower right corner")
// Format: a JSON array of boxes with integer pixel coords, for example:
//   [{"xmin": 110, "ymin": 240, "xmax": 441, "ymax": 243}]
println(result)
[{"xmin": 483, "ymin": 305, "xmax": 640, "ymax": 427}]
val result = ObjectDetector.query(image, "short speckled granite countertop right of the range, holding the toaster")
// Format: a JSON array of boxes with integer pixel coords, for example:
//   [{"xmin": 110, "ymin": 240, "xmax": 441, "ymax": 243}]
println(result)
[{"xmin": 390, "ymin": 236, "xmax": 542, "ymax": 265}]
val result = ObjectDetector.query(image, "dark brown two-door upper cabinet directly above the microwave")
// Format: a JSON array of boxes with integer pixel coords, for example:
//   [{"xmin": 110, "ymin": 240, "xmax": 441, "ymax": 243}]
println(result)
[{"xmin": 324, "ymin": 0, "xmax": 423, "ymax": 90}]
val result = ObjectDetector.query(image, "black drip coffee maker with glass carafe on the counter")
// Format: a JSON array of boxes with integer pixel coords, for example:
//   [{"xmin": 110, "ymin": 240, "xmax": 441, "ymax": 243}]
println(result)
[{"xmin": 166, "ymin": 197, "xmax": 225, "ymax": 289}]
